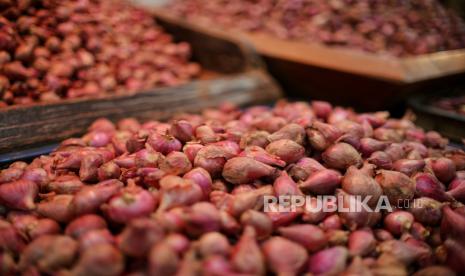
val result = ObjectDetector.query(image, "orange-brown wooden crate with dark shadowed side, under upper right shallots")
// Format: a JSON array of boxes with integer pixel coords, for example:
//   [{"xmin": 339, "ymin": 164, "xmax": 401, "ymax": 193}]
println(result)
[{"xmin": 154, "ymin": 7, "xmax": 465, "ymax": 110}]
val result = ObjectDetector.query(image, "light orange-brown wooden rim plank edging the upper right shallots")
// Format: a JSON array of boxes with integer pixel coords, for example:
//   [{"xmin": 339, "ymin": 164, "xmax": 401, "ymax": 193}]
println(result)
[{"xmin": 154, "ymin": 7, "xmax": 465, "ymax": 84}]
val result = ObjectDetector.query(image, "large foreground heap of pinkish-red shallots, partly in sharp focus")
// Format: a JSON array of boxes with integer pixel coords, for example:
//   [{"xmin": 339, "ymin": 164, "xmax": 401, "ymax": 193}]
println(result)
[{"xmin": 0, "ymin": 101, "xmax": 465, "ymax": 276}]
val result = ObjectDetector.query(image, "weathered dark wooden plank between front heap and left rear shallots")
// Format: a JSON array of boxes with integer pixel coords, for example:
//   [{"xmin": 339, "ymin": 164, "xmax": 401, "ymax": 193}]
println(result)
[{"xmin": 0, "ymin": 70, "xmax": 280, "ymax": 152}]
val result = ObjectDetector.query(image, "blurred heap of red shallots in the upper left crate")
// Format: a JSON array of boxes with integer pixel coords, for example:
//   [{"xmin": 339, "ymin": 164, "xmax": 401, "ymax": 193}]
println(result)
[{"xmin": 0, "ymin": 0, "xmax": 200, "ymax": 107}]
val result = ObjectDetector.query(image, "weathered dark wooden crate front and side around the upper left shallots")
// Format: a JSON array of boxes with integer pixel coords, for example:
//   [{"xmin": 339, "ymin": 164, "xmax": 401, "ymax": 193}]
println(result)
[{"xmin": 0, "ymin": 15, "xmax": 281, "ymax": 153}]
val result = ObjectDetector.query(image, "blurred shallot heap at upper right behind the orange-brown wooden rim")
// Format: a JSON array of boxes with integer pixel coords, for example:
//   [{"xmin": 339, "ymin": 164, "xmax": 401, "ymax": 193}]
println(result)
[{"xmin": 168, "ymin": 0, "xmax": 465, "ymax": 56}]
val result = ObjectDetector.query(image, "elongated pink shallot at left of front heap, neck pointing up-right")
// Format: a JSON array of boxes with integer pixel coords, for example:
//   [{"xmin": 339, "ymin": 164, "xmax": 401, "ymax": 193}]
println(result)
[{"xmin": 71, "ymin": 179, "xmax": 123, "ymax": 215}]
